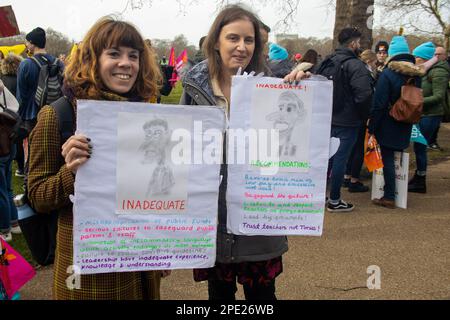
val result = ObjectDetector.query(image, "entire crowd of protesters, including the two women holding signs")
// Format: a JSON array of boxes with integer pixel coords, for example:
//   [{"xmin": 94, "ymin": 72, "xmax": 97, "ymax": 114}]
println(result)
[{"xmin": 0, "ymin": 5, "xmax": 450, "ymax": 300}]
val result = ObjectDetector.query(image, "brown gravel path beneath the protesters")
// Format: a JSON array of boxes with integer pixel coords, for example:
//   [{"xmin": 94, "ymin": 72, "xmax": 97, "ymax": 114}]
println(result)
[{"xmin": 21, "ymin": 124, "xmax": 450, "ymax": 300}]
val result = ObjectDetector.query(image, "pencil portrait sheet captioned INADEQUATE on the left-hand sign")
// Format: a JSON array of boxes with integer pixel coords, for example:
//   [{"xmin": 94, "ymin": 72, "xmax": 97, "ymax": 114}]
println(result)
[{"xmin": 117, "ymin": 112, "xmax": 192, "ymax": 214}]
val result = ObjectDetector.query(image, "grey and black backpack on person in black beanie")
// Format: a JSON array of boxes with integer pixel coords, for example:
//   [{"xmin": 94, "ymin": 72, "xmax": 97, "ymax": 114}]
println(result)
[{"xmin": 31, "ymin": 55, "xmax": 63, "ymax": 108}]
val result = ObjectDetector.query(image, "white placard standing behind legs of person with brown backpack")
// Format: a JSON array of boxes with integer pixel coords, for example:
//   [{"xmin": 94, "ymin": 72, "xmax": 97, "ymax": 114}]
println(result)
[{"xmin": 372, "ymin": 152, "xmax": 409, "ymax": 209}]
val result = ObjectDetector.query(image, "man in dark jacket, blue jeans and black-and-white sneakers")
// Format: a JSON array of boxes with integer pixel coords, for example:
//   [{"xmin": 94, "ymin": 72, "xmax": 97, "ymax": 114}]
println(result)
[{"xmin": 317, "ymin": 28, "xmax": 373, "ymax": 212}]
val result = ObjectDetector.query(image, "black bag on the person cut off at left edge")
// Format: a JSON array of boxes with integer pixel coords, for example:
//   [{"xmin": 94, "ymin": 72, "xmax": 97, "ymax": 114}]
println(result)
[{"xmin": 0, "ymin": 92, "xmax": 28, "ymax": 157}]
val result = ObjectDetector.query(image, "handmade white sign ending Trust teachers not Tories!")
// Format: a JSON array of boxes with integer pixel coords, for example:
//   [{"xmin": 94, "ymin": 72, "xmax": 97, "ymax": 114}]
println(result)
[{"xmin": 227, "ymin": 76, "xmax": 332, "ymax": 236}]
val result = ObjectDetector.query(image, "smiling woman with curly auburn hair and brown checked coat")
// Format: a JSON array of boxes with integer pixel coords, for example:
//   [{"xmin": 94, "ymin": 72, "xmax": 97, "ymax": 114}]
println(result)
[{"xmin": 28, "ymin": 17, "xmax": 169, "ymax": 300}]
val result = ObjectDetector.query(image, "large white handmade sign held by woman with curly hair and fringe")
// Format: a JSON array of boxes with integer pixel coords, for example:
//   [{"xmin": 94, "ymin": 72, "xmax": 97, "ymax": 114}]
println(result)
[{"xmin": 73, "ymin": 100, "xmax": 225, "ymax": 274}]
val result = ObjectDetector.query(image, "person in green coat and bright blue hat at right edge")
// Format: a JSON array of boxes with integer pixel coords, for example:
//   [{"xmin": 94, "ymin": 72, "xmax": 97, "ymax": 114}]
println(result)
[{"xmin": 408, "ymin": 42, "xmax": 450, "ymax": 193}]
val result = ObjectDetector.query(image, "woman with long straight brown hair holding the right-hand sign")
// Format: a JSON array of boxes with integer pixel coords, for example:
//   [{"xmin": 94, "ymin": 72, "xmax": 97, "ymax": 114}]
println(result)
[{"xmin": 180, "ymin": 5, "xmax": 288, "ymax": 300}]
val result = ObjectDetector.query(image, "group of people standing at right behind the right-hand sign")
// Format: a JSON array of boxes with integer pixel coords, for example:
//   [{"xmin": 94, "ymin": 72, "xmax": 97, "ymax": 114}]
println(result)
[{"xmin": 285, "ymin": 28, "xmax": 450, "ymax": 212}]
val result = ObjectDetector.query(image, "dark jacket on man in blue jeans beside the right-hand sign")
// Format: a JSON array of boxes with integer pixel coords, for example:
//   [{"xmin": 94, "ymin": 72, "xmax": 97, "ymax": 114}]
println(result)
[{"xmin": 332, "ymin": 48, "xmax": 373, "ymax": 127}]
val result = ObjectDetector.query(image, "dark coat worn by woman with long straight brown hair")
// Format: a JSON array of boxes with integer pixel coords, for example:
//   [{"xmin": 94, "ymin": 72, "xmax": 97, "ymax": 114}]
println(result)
[{"xmin": 180, "ymin": 61, "xmax": 288, "ymax": 263}]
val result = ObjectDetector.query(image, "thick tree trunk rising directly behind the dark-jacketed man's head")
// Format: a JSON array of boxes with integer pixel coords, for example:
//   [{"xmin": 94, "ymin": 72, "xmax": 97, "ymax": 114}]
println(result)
[{"xmin": 333, "ymin": 0, "xmax": 374, "ymax": 49}]
